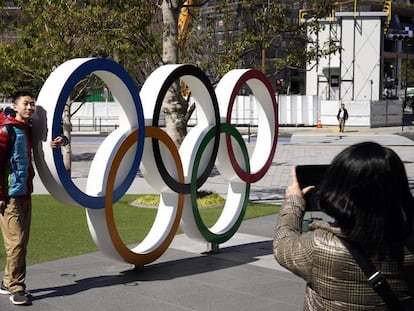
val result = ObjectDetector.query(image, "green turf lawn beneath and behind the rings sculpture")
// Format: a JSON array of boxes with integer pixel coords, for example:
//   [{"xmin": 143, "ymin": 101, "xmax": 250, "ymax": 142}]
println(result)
[{"xmin": 0, "ymin": 195, "xmax": 279, "ymax": 271}]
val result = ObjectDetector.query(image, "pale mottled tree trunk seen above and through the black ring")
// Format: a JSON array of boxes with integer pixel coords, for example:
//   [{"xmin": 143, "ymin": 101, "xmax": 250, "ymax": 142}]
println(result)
[{"xmin": 161, "ymin": 0, "xmax": 188, "ymax": 147}]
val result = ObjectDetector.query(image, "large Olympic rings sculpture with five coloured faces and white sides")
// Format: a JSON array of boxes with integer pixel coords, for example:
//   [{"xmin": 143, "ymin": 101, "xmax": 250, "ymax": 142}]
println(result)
[{"xmin": 33, "ymin": 58, "xmax": 278, "ymax": 265}]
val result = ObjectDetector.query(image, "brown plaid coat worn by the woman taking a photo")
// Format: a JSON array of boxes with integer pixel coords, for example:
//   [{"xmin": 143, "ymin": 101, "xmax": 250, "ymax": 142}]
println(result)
[{"xmin": 273, "ymin": 195, "xmax": 414, "ymax": 311}]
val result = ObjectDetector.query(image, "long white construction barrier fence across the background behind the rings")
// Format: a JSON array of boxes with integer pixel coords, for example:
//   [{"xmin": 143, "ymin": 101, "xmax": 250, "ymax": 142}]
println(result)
[{"xmin": 0, "ymin": 95, "xmax": 403, "ymax": 132}]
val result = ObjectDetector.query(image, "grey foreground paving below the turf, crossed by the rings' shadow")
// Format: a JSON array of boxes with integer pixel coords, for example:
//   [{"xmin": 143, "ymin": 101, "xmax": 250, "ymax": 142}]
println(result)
[{"xmin": 0, "ymin": 216, "xmax": 305, "ymax": 311}]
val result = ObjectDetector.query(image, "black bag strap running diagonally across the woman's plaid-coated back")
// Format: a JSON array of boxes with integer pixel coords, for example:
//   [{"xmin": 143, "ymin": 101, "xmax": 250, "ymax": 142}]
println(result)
[{"xmin": 340, "ymin": 238, "xmax": 404, "ymax": 311}]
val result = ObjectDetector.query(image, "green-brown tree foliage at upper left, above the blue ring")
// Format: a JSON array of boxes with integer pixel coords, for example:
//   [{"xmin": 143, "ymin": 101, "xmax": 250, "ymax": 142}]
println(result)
[{"xmin": 0, "ymin": 0, "xmax": 160, "ymax": 94}]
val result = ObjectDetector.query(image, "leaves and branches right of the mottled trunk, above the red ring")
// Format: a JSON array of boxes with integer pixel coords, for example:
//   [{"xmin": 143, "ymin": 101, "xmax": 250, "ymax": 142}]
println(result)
[{"xmin": 181, "ymin": 0, "xmax": 339, "ymax": 81}]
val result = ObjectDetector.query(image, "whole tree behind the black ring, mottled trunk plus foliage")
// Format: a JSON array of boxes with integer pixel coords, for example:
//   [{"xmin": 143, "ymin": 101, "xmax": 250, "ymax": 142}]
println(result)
[{"xmin": 160, "ymin": 0, "xmax": 338, "ymax": 145}]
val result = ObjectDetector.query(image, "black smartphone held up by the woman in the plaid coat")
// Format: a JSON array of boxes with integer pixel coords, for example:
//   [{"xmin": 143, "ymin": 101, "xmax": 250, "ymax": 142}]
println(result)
[{"xmin": 296, "ymin": 164, "xmax": 329, "ymax": 211}]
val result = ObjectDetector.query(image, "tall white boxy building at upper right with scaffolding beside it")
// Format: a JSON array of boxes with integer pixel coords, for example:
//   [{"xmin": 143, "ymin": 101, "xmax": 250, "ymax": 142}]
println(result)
[{"xmin": 306, "ymin": 1, "xmax": 414, "ymax": 127}]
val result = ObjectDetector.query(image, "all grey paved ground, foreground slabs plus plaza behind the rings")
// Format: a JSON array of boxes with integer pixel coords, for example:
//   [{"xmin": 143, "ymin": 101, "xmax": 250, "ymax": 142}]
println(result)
[{"xmin": 0, "ymin": 125, "xmax": 414, "ymax": 311}]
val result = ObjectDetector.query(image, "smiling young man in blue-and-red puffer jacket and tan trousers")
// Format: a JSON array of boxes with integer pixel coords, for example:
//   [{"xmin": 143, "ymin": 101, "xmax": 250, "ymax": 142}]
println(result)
[{"xmin": 0, "ymin": 91, "xmax": 62, "ymax": 305}]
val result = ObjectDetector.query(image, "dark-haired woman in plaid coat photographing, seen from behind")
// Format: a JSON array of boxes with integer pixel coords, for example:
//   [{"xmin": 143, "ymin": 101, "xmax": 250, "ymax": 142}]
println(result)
[{"xmin": 273, "ymin": 142, "xmax": 414, "ymax": 311}]
